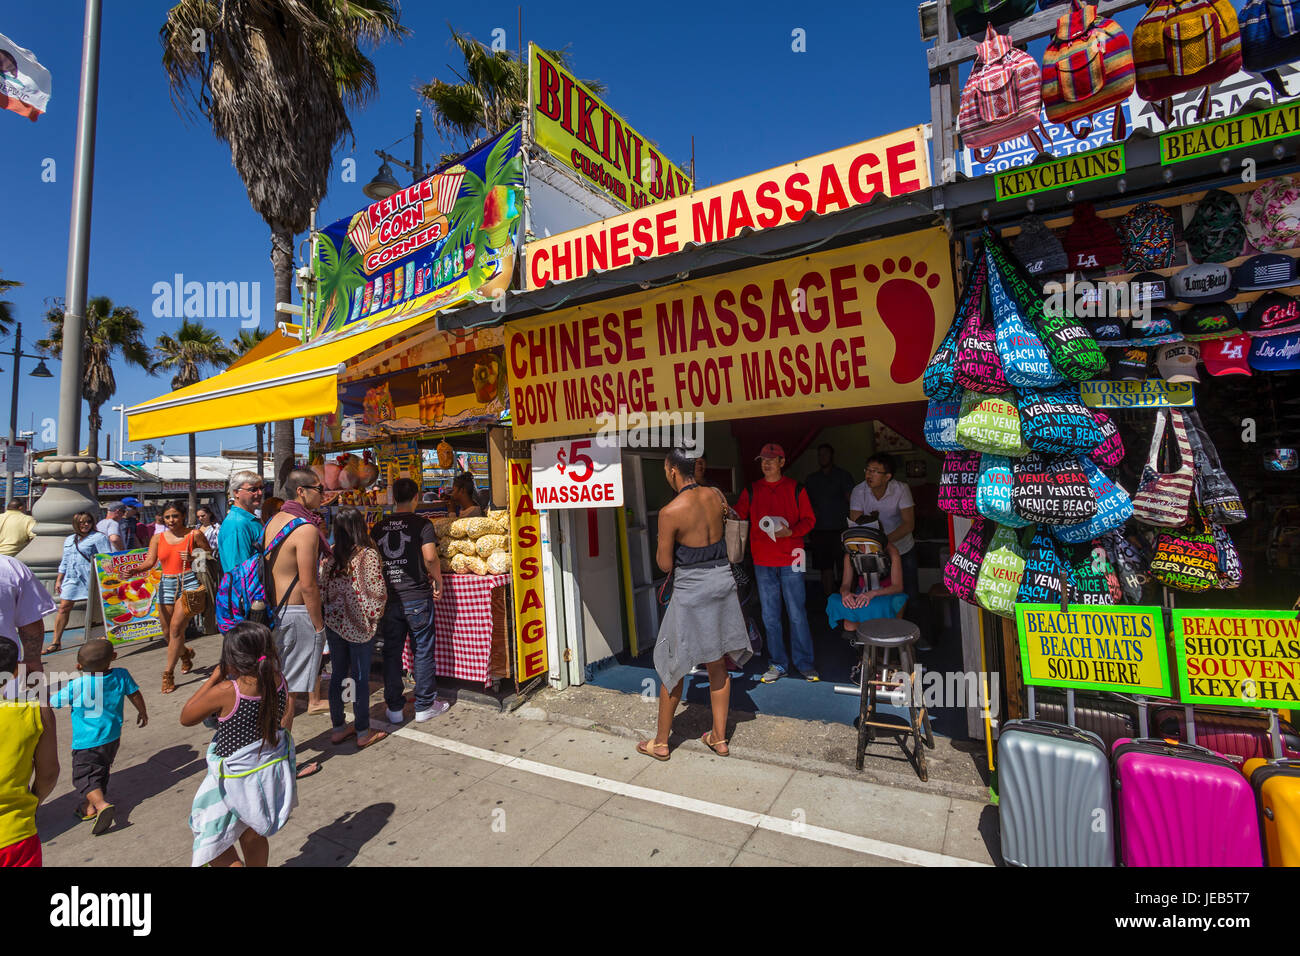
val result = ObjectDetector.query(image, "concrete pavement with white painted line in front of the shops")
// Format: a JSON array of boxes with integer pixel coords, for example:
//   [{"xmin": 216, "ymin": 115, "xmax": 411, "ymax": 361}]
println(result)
[{"xmin": 38, "ymin": 637, "xmax": 997, "ymax": 866}]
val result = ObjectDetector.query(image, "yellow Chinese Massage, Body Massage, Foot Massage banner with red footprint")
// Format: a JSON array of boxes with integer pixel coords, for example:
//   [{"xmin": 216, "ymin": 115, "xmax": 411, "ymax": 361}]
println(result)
[{"xmin": 506, "ymin": 229, "xmax": 954, "ymax": 441}]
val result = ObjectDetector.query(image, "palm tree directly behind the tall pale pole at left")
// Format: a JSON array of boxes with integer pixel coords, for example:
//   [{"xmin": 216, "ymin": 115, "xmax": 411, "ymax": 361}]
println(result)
[{"xmin": 36, "ymin": 295, "xmax": 153, "ymax": 481}]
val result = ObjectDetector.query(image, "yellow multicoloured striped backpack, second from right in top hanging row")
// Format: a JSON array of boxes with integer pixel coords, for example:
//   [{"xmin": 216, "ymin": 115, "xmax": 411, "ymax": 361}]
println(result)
[{"xmin": 1132, "ymin": 0, "xmax": 1242, "ymax": 126}]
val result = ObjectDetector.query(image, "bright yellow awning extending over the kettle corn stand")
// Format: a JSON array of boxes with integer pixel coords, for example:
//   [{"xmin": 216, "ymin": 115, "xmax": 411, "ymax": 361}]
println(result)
[{"xmin": 126, "ymin": 314, "xmax": 434, "ymax": 441}]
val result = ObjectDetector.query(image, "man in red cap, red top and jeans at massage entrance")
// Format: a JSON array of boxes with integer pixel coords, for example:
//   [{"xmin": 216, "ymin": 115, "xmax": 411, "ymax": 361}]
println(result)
[{"xmin": 736, "ymin": 442, "xmax": 822, "ymax": 684}]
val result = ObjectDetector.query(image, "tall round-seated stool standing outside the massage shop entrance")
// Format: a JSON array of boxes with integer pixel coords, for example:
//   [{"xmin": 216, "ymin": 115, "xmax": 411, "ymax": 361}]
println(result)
[{"xmin": 854, "ymin": 618, "xmax": 935, "ymax": 780}]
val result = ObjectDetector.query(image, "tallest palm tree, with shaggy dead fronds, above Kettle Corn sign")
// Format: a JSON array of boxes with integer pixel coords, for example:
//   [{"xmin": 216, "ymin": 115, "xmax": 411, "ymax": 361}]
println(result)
[{"xmin": 160, "ymin": 0, "xmax": 410, "ymax": 492}]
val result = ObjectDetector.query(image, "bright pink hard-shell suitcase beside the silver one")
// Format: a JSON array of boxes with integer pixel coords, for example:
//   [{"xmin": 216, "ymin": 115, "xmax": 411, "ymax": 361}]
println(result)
[{"xmin": 1110, "ymin": 739, "xmax": 1264, "ymax": 866}]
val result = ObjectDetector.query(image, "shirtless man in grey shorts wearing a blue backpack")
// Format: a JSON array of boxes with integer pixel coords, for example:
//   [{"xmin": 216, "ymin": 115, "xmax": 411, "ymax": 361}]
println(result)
[{"xmin": 263, "ymin": 468, "xmax": 329, "ymax": 777}]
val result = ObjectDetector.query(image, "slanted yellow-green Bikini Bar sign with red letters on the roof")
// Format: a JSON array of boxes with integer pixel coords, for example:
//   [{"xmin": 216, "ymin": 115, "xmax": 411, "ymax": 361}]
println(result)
[{"xmin": 528, "ymin": 43, "xmax": 693, "ymax": 209}]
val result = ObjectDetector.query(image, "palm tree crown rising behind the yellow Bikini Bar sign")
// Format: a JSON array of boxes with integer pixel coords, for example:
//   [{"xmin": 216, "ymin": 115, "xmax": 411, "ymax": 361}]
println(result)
[{"xmin": 416, "ymin": 29, "xmax": 606, "ymax": 161}]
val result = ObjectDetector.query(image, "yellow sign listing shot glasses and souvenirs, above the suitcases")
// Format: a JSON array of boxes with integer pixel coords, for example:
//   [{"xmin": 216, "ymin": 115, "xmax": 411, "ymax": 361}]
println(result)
[{"xmin": 1174, "ymin": 610, "xmax": 1300, "ymax": 709}]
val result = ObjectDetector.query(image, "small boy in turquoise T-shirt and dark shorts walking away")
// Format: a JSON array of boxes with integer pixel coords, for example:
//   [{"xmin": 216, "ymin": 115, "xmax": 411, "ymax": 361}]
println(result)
[{"xmin": 49, "ymin": 640, "xmax": 150, "ymax": 836}]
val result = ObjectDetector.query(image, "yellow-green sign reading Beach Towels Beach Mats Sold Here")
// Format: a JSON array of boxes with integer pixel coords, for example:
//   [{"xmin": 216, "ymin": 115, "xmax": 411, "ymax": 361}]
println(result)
[{"xmin": 1015, "ymin": 604, "xmax": 1171, "ymax": 697}]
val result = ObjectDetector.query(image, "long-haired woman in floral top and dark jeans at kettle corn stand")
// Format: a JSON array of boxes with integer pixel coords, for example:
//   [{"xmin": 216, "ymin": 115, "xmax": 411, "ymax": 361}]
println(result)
[{"xmin": 321, "ymin": 507, "xmax": 387, "ymax": 747}]
